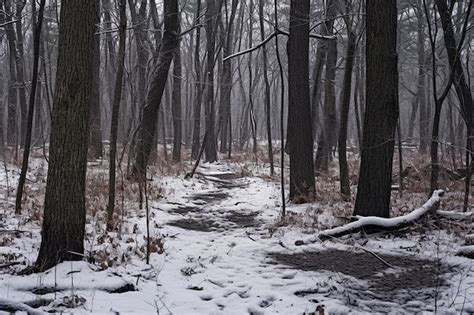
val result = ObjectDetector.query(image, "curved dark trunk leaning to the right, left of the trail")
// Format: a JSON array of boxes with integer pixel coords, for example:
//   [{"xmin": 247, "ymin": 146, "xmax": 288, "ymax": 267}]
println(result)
[{"xmin": 131, "ymin": 0, "xmax": 179, "ymax": 181}]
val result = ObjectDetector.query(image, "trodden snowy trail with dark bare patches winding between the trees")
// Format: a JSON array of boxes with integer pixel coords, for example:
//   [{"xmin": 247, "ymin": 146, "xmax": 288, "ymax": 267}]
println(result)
[{"xmin": 151, "ymin": 164, "xmax": 460, "ymax": 314}]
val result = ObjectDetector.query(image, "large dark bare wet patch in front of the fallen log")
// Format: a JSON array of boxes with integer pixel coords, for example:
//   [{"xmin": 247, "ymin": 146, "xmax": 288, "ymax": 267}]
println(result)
[{"xmin": 269, "ymin": 249, "xmax": 448, "ymax": 304}]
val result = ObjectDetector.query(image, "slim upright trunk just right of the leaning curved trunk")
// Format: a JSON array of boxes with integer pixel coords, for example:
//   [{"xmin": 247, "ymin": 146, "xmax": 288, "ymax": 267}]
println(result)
[{"xmin": 171, "ymin": 43, "xmax": 183, "ymax": 162}]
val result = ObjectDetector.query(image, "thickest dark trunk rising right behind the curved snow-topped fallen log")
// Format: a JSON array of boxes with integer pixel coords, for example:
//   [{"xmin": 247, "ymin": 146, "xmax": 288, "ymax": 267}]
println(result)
[{"xmin": 354, "ymin": 0, "xmax": 399, "ymax": 218}]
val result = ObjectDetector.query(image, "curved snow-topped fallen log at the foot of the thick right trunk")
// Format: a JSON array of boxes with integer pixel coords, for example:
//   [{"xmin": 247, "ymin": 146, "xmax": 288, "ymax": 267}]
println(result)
[{"xmin": 295, "ymin": 190, "xmax": 444, "ymax": 246}]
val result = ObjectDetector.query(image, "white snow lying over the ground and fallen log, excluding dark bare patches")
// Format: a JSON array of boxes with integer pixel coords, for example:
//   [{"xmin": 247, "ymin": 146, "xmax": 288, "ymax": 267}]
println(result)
[{"xmin": 0, "ymin": 163, "xmax": 474, "ymax": 314}]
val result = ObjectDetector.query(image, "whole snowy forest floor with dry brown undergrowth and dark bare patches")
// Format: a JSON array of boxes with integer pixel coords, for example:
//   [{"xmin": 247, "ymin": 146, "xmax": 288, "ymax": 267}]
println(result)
[{"xmin": 0, "ymin": 149, "xmax": 474, "ymax": 314}]
